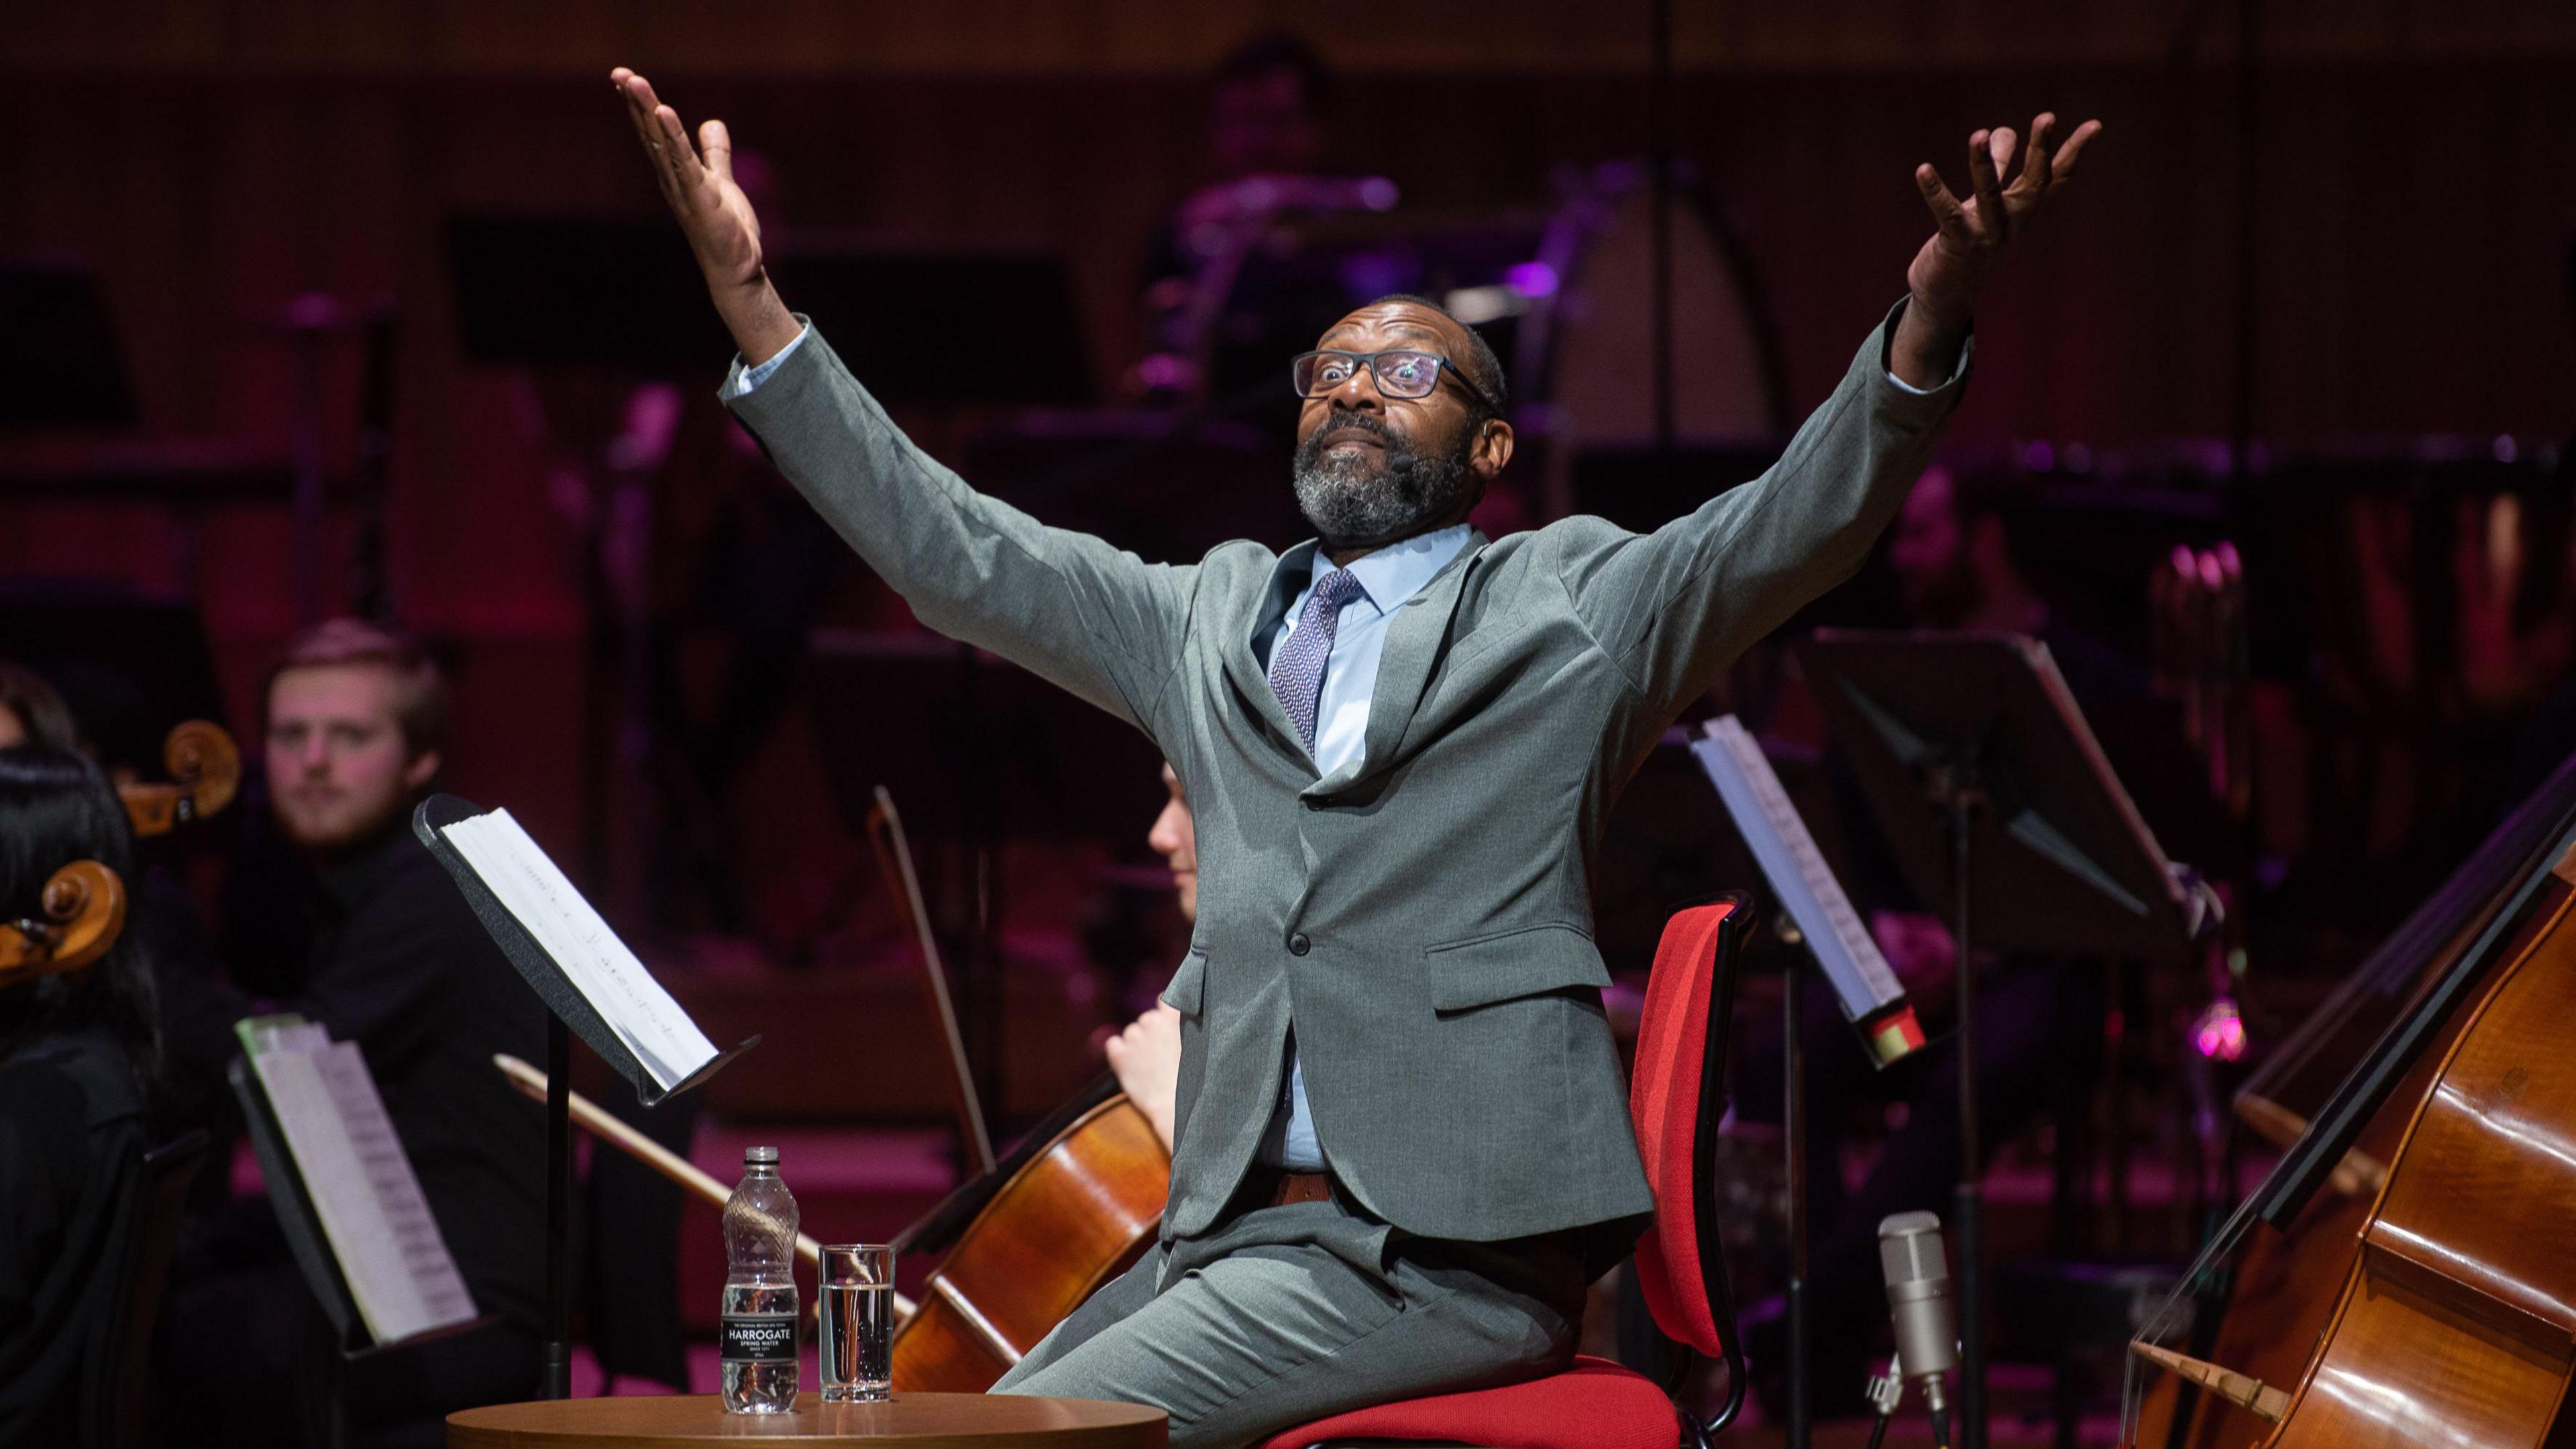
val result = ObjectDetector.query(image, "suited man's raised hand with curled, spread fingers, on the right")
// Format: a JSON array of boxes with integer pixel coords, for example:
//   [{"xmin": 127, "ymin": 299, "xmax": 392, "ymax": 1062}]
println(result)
[{"xmin": 1896, "ymin": 111, "xmax": 2102, "ymax": 387}]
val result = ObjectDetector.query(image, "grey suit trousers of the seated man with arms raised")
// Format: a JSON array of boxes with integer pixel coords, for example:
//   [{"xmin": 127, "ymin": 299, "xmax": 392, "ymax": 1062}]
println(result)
[{"xmin": 991, "ymin": 1199, "xmax": 1587, "ymax": 1449}]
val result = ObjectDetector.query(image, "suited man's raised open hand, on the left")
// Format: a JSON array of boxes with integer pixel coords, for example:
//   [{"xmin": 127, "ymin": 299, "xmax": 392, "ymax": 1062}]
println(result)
[{"xmin": 608, "ymin": 64, "xmax": 798, "ymax": 364}]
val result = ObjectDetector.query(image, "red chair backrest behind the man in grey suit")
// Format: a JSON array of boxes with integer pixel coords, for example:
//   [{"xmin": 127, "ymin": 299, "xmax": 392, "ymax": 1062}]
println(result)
[{"xmin": 1628, "ymin": 898, "xmax": 1752, "ymax": 1356}]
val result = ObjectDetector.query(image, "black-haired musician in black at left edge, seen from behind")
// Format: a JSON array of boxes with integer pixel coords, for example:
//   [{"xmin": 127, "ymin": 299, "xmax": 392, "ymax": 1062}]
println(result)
[{"xmin": 0, "ymin": 742, "xmax": 160, "ymax": 1444}]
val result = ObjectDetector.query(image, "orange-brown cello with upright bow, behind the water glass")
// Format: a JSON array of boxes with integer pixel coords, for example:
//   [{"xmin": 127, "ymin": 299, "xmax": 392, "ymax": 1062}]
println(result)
[{"xmin": 868, "ymin": 786, "xmax": 1172, "ymax": 1392}]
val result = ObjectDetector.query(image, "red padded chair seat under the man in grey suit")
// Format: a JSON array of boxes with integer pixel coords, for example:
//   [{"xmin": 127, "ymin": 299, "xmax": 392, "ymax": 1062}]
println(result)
[{"xmin": 1260, "ymin": 1356, "xmax": 1682, "ymax": 1449}]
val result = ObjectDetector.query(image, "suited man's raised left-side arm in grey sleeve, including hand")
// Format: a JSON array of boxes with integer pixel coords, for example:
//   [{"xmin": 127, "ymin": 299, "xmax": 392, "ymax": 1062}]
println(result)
[{"xmin": 610, "ymin": 67, "xmax": 1198, "ymax": 730}]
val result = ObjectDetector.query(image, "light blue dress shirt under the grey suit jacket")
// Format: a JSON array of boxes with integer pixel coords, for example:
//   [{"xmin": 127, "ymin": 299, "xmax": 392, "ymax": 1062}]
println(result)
[{"xmin": 1252, "ymin": 523, "xmax": 1468, "ymax": 1173}]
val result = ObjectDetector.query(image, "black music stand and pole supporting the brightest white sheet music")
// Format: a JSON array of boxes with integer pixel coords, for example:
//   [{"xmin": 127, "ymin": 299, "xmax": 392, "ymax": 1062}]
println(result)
[{"xmin": 412, "ymin": 794, "xmax": 760, "ymax": 1397}]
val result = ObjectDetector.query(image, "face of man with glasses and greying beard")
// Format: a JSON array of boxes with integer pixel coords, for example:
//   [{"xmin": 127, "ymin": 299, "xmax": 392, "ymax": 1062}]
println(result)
[{"xmin": 1296, "ymin": 302, "xmax": 1512, "ymax": 549}]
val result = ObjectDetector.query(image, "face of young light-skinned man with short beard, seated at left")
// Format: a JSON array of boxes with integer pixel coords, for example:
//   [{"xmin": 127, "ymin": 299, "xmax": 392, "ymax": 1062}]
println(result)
[{"xmin": 268, "ymin": 665, "xmax": 438, "ymax": 851}]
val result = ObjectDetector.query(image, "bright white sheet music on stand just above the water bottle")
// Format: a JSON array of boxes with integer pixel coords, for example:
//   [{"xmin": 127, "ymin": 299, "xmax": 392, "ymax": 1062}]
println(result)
[{"xmin": 445, "ymin": 810, "xmax": 716, "ymax": 1091}]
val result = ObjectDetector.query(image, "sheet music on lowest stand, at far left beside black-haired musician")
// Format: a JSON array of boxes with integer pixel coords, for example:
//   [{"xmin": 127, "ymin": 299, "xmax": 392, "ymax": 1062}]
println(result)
[{"xmin": 250, "ymin": 1026, "xmax": 474, "ymax": 1343}]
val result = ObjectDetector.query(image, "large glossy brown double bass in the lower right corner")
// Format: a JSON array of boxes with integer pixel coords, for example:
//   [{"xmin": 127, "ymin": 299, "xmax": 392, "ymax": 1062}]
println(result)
[{"xmin": 2128, "ymin": 763, "xmax": 2576, "ymax": 1449}]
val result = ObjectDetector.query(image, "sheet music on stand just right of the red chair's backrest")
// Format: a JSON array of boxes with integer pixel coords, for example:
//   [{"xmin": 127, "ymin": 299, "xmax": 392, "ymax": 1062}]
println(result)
[{"xmin": 1690, "ymin": 714, "xmax": 1907, "ymax": 1021}]
